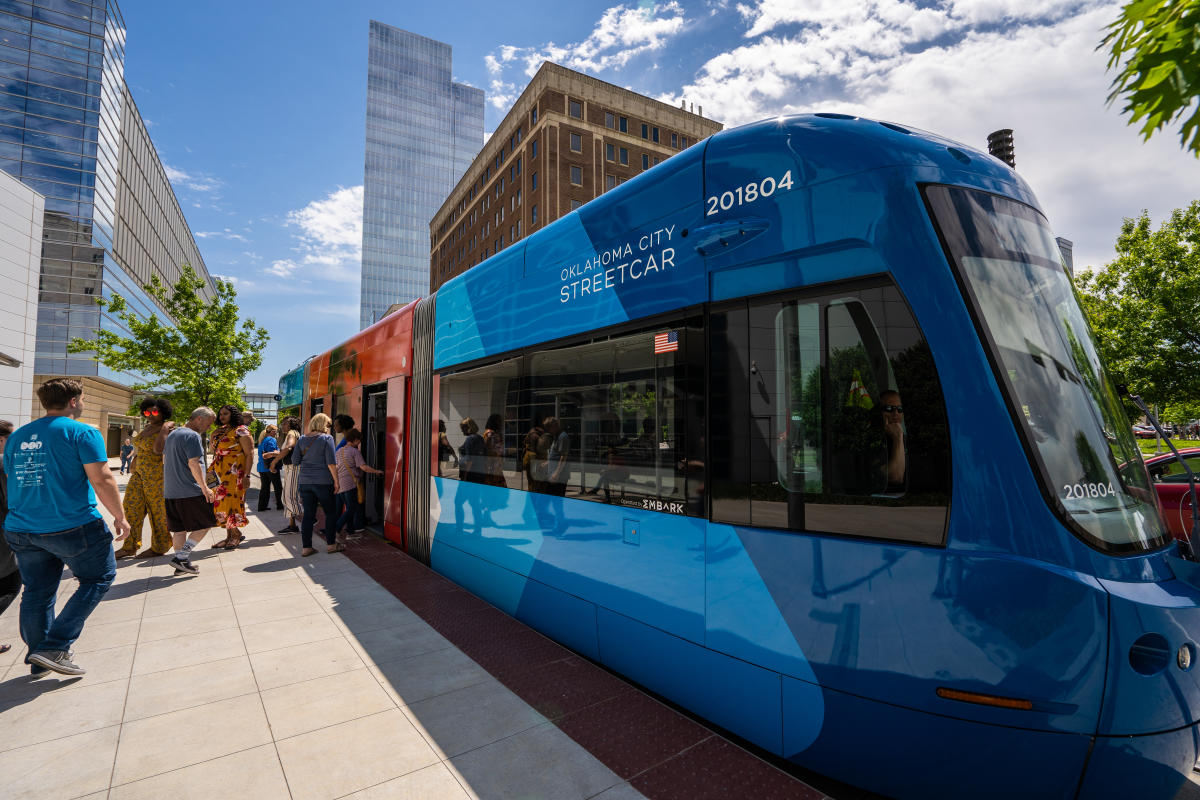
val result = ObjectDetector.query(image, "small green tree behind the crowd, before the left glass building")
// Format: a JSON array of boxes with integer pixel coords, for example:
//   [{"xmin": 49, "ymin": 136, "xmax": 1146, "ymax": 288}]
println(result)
[{"xmin": 67, "ymin": 264, "xmax": 270, "ymax": 414}]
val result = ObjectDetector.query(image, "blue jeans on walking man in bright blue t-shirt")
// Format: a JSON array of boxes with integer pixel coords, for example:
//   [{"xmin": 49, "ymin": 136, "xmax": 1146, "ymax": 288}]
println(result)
[{"xmin": 5, "ymin": 519, "xmax": 116, "ymax": 652}]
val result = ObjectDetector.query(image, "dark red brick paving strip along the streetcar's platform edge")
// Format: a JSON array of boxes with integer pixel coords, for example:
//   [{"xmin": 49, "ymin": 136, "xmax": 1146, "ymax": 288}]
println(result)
[{"xmin": 346, "ymin": 536, "xmax": 824, "ymax": 800}]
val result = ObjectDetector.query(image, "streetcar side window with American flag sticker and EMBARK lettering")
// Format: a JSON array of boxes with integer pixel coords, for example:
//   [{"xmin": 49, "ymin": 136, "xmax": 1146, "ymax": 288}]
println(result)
[{"xmin": 521, "ymin": 319, "xmax": 704, "ymax": 516}]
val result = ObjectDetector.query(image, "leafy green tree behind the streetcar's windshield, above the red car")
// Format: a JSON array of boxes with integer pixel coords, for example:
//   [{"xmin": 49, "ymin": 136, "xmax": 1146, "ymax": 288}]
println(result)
[{"xmin": 1075, "ymin": 200, "xmax": 1200, "ymax": 405}]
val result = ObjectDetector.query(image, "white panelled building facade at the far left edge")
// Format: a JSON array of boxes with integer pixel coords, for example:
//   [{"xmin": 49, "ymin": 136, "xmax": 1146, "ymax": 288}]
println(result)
[{"xmin": 0, "ymin": 172, "xmax": 46, "ymax": 426}]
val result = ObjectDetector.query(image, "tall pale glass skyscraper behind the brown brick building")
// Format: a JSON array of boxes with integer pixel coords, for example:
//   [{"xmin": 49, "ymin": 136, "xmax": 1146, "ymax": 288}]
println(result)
[{"xmin": 360, "ymin": 20, "xmax": 484, "ymax": 327}]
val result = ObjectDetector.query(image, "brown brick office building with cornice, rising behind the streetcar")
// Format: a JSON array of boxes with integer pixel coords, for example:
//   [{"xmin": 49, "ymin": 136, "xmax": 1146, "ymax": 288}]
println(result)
[{"xmin": 430, "ymin": 61, "xmax": 721, "ymax": 291}]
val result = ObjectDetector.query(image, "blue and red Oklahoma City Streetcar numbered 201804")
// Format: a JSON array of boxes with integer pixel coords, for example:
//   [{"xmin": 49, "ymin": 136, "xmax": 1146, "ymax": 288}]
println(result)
[{"xmin": 281, "ymin": 114, "xmax": 1200, "ymax": 799}]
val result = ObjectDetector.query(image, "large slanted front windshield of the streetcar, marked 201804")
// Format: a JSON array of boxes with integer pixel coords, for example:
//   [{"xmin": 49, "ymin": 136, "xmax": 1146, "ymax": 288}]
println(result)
[{"xmin": 925, "ymin": 186, "xmax": 1168, "ymax": 553}]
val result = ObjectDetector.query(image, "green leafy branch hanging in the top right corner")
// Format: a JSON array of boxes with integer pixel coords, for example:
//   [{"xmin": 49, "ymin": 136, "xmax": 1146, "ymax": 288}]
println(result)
[{"xmin": 1100, "ymin": 0, "xmax": 1200, "ymax": 156}]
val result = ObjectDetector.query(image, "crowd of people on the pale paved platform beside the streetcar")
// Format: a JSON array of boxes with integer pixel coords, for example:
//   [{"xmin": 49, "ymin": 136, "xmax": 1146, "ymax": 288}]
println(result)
[{"xmin": 0, "ymin": 378, "xmax": 379, "ymax": 678}]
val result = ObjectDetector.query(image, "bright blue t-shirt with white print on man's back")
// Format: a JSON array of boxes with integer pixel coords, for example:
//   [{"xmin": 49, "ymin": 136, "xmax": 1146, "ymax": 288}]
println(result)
[{"xmin": 4, "ymin": 416, "xmax": 108, "ymax": 534}]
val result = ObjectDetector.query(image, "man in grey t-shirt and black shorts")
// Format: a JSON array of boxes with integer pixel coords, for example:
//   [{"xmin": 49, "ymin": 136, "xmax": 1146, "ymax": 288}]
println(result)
[{"xmin": 162, "ymin": 405, "xmax": 217, "ymax": 575}]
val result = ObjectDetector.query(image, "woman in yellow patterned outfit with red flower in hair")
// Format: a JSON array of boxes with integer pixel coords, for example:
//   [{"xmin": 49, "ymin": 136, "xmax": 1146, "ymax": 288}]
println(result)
[{"xmin": 116, "ymin": 397, "xmax": 175, "ymax": 559}]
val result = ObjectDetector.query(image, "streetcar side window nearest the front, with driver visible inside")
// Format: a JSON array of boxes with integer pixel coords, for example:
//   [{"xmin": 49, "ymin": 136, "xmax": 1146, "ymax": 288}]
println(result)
[{"xmin": 709, "ymin": 278, "xmax": 949, "ymax": 545}]
